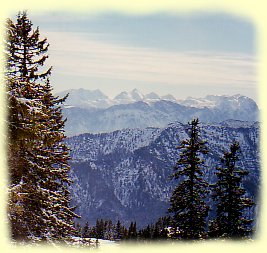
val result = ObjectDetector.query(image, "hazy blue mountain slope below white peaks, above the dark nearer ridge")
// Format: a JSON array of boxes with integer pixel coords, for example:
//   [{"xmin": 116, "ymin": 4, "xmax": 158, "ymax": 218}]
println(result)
[{"xmin": 63, "ymin": 96, "xmax": 259, "ymax": 136}]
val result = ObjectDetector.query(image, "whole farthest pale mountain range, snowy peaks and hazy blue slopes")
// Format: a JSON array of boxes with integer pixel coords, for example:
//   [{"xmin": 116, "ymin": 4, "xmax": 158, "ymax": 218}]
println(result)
[{"xmin": 57, "ymin": 89, "xmax": 259, "ymax": 136}]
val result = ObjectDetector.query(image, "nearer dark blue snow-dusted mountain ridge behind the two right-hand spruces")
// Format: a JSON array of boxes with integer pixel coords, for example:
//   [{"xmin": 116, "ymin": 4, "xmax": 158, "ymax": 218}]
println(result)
[{"xmin": 66, "ymin": 120, "xmax": 260, "ymax": 227}]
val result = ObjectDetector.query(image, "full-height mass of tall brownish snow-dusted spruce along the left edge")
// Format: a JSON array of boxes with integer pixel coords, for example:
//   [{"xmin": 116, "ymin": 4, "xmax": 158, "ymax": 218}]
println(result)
[{"xmin": 5, "ymin": 12, "xmax": 76, "ymax": 240}]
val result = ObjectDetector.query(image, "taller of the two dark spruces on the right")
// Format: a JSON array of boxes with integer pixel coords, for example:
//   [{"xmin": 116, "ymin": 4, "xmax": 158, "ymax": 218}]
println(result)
[{"xmin": 169, "ymin": 119, "xmax": 209, "ymax": 239}]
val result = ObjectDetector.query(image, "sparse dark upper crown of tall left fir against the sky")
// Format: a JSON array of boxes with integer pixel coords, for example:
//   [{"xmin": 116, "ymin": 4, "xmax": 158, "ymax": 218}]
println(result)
[{"xmin": 5, "ymin": 12, "xmax": 52, "ymax": 82}]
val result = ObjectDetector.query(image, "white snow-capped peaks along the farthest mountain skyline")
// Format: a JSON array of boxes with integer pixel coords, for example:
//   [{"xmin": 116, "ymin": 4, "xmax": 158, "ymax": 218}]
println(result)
[{"xmin": 56, "ymin": 88, "xmax": 257, "ymax": 109}]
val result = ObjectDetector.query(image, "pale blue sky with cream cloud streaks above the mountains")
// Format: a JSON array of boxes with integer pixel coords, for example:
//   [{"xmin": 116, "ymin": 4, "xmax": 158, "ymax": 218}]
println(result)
[{"xmin": 29, "ymin": 12, "xmax": 258, "ymax": 100}]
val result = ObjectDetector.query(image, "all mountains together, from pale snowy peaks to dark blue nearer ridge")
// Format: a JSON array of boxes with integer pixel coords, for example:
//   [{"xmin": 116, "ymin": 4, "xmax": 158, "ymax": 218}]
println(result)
[{"xmin": 58, "ymin": 89, "xmax": 260, "ymax": 227}]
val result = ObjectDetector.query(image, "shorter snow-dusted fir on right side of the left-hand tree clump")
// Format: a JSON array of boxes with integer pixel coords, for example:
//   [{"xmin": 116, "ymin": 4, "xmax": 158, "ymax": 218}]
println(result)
[{"xmin": 35, "ymin": 81, "xmax": 78, "ymax": 238}]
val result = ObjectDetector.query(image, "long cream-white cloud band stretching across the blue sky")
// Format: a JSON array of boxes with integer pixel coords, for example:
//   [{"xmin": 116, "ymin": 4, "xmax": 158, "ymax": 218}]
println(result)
[{"xmin": 46, "ymin": 32, "xmax": 257, "ymax": 88}]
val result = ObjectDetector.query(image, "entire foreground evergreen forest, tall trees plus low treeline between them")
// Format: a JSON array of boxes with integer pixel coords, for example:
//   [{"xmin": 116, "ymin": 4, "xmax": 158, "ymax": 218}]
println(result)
[{"xmin": 5, "ymin": 12, "xmax": 255, "ymax": 243}]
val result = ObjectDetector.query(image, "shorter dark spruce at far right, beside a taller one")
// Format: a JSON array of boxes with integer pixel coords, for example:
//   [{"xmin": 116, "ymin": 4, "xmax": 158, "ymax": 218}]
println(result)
[{"xmin": 209, "ymin": 142, "xmax": 254, "ymax": 238}]
